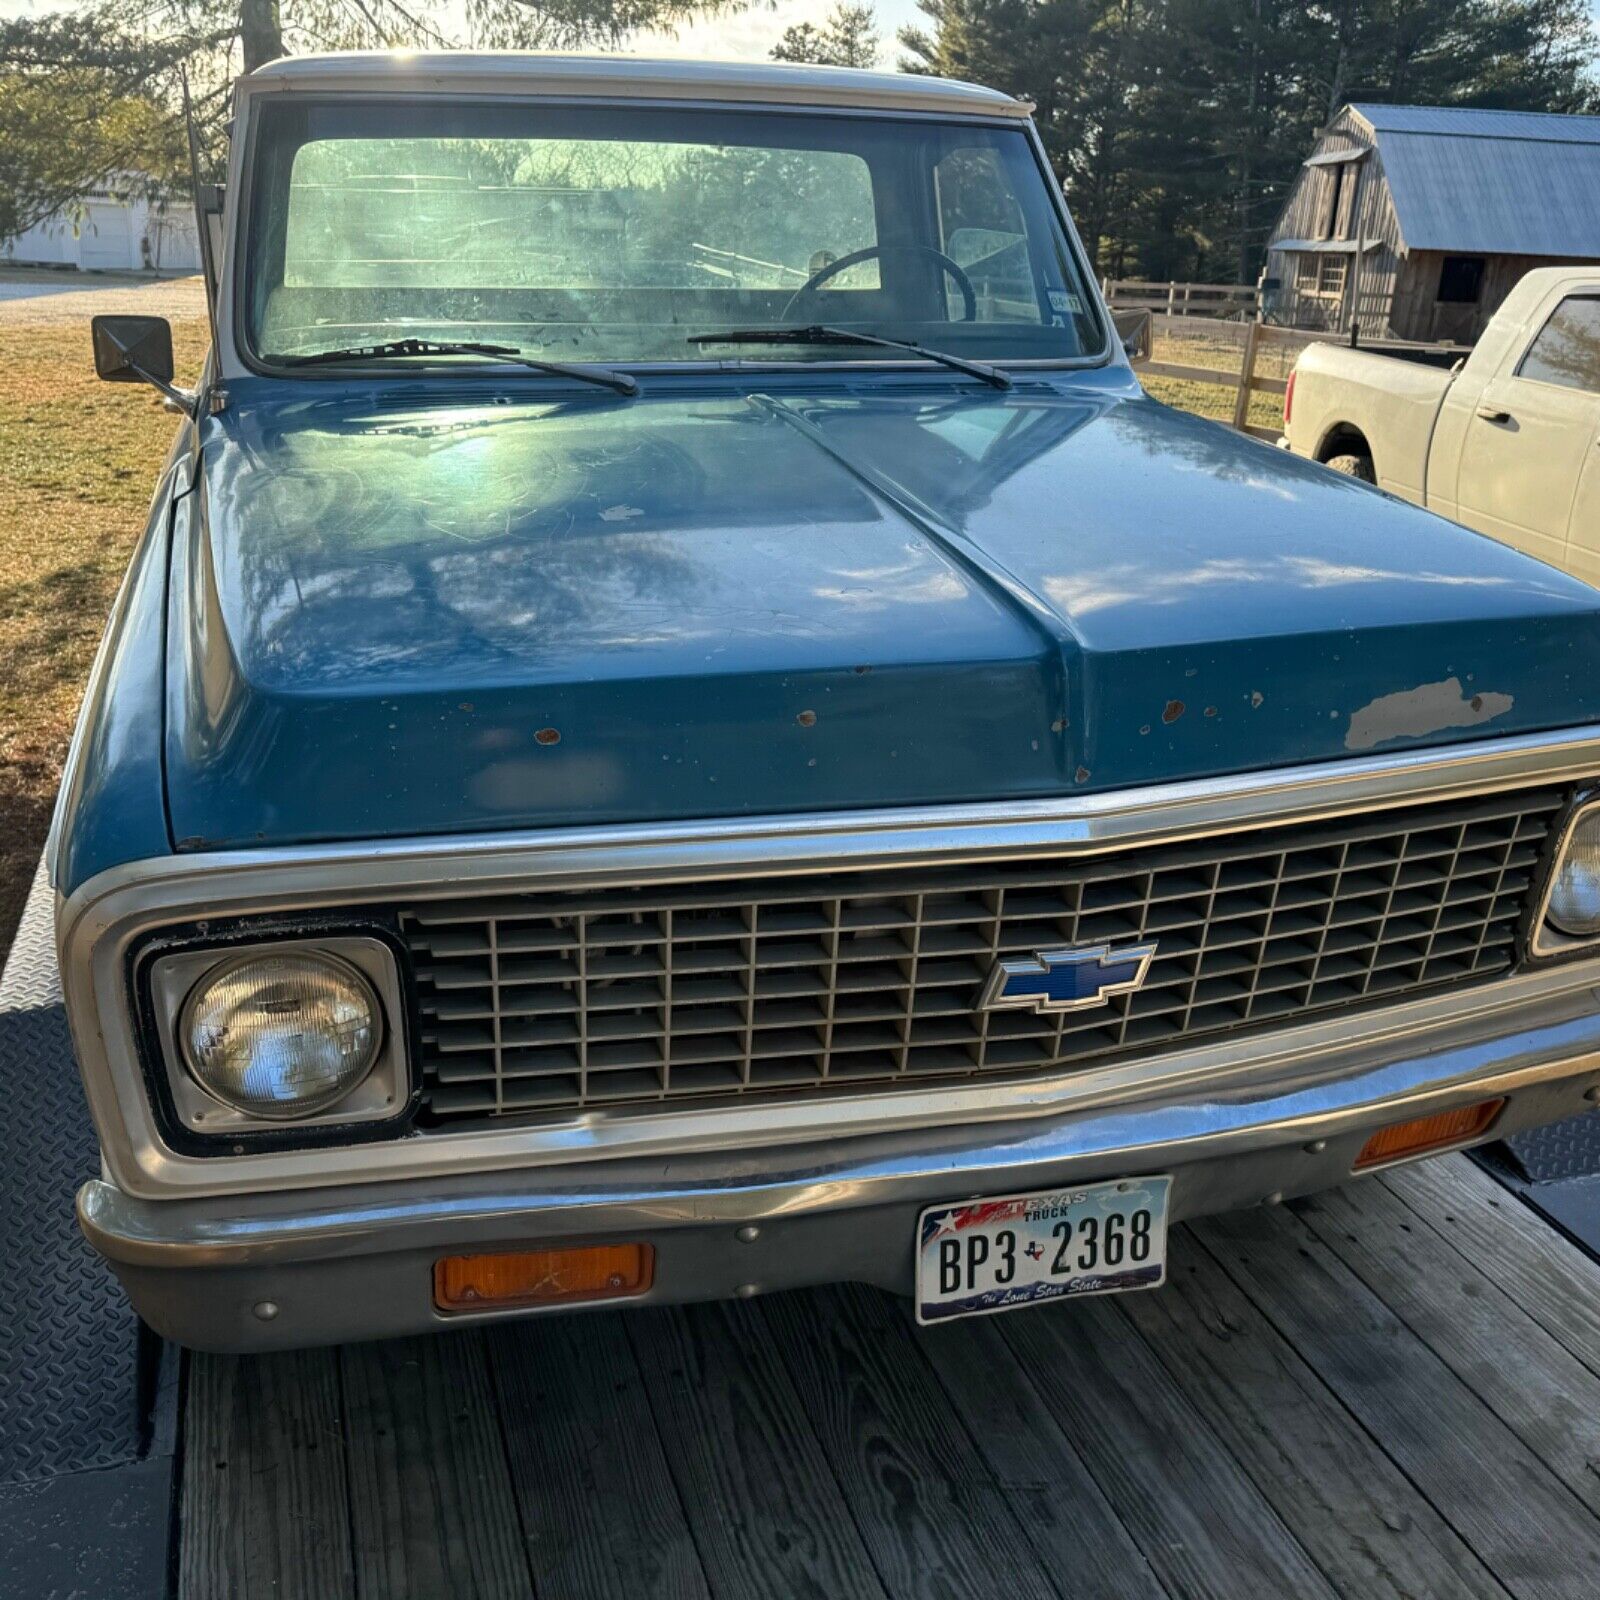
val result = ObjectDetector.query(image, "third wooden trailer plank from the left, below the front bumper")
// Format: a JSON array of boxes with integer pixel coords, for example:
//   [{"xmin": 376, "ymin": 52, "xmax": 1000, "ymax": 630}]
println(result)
[{"xmin": 488, "ymin": 1312, "xmax": 710, "ymax": 1600}]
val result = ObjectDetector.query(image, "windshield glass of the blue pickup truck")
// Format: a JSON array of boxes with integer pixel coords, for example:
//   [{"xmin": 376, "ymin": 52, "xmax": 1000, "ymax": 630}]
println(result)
[{"xmin": 243, "ymin": 101, "xmax": 1102, "ymax": 363}]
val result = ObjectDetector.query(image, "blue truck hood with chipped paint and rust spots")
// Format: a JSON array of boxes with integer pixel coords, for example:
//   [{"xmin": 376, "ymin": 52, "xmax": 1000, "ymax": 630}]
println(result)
[{"xmin": 165, "ymin": 374, "xmax": 1600, "ymax": 848}]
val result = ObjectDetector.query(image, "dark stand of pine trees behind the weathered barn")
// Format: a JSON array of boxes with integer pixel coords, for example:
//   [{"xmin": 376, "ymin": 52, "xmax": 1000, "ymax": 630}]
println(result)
[{"xmin": 899, "ymin": 0, "xmax": 1600, "ymax": 283}]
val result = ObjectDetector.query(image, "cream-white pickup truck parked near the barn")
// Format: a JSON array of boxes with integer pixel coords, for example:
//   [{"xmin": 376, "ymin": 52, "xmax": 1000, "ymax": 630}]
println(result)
[{"xmin": 1283, "ymin": 266, "xmax": 1600, "ymax": 584}]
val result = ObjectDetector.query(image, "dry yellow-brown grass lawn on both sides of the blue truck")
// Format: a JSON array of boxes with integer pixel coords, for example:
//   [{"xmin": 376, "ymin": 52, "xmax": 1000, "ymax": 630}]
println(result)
[{"xmin": 0, "ymin": 318, "xmax": 1280, "ymax": 958}]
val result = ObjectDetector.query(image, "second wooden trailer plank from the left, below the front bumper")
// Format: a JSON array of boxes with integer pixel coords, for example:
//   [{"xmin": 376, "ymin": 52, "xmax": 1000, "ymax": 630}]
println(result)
[{"xmin": 339, "ymin": 1333, "xmax": 528, "ymax": 1600}]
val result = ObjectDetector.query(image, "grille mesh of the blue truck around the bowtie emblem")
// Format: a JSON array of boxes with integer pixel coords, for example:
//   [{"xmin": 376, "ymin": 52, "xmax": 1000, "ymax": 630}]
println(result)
[{"xmin": 400, "ymin": 790, "xmax": 1565, "ymax": 1126}]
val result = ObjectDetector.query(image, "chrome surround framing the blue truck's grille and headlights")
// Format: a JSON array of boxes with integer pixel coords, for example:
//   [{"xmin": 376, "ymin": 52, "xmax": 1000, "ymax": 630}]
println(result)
[{"xmin": 59, "ymin": 728, "xmax": 1600, "ymax": 1197}]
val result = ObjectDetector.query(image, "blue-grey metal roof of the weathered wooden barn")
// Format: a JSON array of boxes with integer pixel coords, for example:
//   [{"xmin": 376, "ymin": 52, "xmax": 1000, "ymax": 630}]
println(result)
[{"xmin": 1350, "ymin": 104, "xmax": 1600, "ymax": 259}]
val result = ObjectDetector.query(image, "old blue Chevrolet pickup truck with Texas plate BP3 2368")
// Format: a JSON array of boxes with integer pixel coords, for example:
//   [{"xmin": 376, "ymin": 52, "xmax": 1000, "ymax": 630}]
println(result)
[{"xmin": 59, "ymin": 54, "xmax": 1600, "ymax": 1349}]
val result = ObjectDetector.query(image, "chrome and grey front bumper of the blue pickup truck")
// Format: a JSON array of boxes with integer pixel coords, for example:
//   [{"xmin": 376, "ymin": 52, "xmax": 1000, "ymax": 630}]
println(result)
[{"xmin": 78, "ymin": 989, "xmax": 1600, "ymax": 1350}]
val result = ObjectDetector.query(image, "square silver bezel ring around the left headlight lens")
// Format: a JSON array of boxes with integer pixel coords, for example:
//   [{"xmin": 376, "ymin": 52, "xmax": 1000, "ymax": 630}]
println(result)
[{"xmin": 146, "ymin": 931, "xmax": 414, "ymax": 1154}]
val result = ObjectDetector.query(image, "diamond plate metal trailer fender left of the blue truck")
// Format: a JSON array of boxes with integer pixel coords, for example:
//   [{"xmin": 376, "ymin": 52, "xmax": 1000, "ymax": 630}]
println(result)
[{"xmin": 0, "ymin": 872, "xmax": 141, "ymax": 1485}]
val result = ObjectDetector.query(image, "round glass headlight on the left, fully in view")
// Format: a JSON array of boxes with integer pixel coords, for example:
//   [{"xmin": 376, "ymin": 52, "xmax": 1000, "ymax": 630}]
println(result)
[{"xmin": 178, "ymin": 954, "xmax": 382, "ymax": 1120}]
